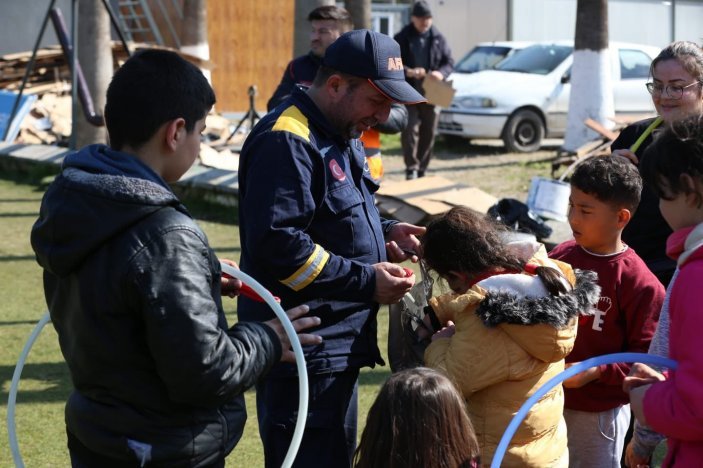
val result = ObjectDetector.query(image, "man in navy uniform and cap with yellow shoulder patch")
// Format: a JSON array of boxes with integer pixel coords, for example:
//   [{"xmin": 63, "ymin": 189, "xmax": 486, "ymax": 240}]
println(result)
[{"xmin": 237, "ymin": 30, "xmax": 424, "ymax": 467}]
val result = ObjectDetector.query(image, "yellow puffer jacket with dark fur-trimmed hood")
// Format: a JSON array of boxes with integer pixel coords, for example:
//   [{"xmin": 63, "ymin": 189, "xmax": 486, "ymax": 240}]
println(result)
[{"xmin": 425, "ymin": 248, "xmax": 599, "ymax": 468}]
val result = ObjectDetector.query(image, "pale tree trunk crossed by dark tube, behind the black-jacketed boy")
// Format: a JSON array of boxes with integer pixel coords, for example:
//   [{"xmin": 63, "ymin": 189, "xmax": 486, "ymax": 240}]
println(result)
[{"xmin": 73, "ymin": 1, "xmax": 112, "ymax": 148}]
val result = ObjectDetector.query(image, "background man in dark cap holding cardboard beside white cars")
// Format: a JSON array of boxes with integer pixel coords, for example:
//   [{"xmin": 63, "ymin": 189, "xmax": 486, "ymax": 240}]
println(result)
[{"xmin": 395, "ymin": 0, "xmax": 454, "ymax": 179}]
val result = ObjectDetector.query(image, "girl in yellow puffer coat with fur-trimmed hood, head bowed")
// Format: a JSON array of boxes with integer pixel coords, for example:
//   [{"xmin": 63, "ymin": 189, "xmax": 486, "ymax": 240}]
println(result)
[{"xmin": 422, "ymin": 207, "xmax": 600, "ymax": 468}]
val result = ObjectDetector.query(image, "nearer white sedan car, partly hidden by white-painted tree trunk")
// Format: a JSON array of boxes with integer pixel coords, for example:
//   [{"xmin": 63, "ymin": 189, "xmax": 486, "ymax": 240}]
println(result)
[{"xmin": 438, "ymin": 42, "xmax": 659, "ymax": 152}]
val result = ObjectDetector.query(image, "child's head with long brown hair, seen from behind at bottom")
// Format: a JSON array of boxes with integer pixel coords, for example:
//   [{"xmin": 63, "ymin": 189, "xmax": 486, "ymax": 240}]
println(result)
[{"xmin": 354, "ymin": 367, "xmax": 478, "ymax": 468}]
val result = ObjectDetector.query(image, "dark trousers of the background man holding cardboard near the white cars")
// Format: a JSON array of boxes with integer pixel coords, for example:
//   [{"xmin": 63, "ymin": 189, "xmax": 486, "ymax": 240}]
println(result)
[{"xmin": 400, "ymin": 104, "xmax": 439, "ymax": 173}]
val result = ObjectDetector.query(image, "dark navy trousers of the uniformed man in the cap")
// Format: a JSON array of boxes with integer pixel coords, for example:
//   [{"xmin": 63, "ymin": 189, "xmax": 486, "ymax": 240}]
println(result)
[{"xmin": 256, "ymin": 369, "xmax": 359, "ymax": 468}]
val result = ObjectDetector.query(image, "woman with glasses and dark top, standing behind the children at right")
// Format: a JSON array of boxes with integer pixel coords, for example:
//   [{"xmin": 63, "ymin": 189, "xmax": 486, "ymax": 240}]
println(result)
[{"xmin": 610, "ymin": 41, "xmax": 703, "ymax": 467}]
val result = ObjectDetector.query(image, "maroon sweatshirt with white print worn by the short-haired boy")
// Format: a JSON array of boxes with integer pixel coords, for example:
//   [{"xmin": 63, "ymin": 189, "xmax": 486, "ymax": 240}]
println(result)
[{"xmin": 549, "ymin": 240, "xmax": 665, "ymax": 412}]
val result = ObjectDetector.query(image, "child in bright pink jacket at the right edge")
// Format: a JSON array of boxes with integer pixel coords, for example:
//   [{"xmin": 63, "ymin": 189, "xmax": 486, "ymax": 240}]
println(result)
[{"xmin": 624, "ymin": 116, "xmax": 703, "ymax": 467}]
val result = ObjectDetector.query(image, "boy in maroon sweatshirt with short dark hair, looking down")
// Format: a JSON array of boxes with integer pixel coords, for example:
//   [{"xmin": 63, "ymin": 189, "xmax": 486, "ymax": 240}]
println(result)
[{"xmin": 549, "ymin": 157, "xmax": 664, "ymax": 468}]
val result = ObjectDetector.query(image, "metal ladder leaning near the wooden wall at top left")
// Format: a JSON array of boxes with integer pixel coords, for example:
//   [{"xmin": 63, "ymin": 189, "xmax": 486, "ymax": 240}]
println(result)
[{"xmin": 117, "ymin": 0, "xmax": 183, "ymax": 48}]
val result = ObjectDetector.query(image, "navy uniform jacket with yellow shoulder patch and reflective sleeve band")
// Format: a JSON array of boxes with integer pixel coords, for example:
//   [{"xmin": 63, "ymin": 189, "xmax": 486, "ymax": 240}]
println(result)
[{"xmin": 238, "ymin": 86, "xmax": 395, "ymax": 374}]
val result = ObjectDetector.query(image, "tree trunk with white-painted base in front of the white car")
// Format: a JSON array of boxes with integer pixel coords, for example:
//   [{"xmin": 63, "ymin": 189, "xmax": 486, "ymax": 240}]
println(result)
[{"xmin": 563, "ymin": 0, "xmax": 615, "ymax": 152}]
